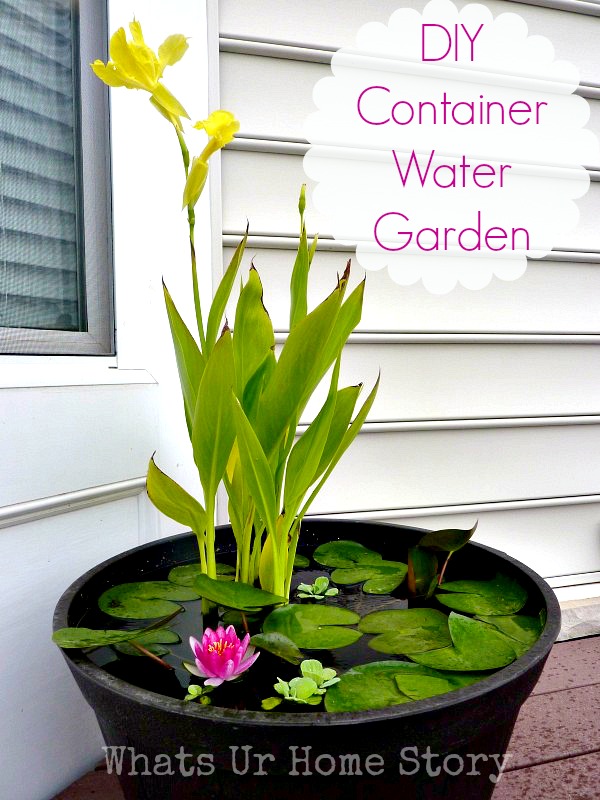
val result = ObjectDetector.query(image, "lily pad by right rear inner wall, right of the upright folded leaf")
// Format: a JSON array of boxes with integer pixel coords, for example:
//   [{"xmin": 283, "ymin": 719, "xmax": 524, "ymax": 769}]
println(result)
[{"xmin": 435, "ymin": 573, "xmax": 527, "ymax": 616}]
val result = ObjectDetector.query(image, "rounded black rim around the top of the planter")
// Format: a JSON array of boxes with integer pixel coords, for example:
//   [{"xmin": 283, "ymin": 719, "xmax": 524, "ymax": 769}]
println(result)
[{"xmin": 53, "ymin": 517, "xmax": 561, "ymax": 728}]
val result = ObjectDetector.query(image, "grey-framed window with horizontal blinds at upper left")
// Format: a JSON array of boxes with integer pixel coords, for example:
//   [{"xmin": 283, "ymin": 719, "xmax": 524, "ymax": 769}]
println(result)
[{"xmin": 0, "ymin": 0, "xmax": 113, "ymax": 355}]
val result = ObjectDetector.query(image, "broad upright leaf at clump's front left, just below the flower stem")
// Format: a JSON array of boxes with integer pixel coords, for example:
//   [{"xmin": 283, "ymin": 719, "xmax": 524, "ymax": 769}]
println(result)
[{"xmin": 192, "ymin": 330, "xmax": 235, "ymax": 503}]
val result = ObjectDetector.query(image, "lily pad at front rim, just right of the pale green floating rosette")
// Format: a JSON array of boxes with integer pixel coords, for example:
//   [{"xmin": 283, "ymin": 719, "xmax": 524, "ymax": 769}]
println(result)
[{"xmin": 325, "ymin": 661, "xmax": 413, "ymax": 712}]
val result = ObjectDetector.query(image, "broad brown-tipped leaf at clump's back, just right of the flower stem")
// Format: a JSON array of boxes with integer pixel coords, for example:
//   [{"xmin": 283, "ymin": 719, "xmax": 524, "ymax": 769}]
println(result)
[{"xmin": 233, "ymin": 267, "xmax": 275, "ymax": 398}]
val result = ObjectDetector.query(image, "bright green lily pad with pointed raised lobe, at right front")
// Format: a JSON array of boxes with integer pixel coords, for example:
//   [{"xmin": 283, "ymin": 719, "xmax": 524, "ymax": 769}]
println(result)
[{"xmin": 409, "ymin": 612, "xmax": 517, "ymax": 672}]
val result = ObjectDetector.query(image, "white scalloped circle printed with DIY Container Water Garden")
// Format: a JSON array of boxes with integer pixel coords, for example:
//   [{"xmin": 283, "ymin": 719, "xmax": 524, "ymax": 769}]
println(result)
[{"xmin": 304, "ymin": 0, "xmax": 600, "ymax": 294}]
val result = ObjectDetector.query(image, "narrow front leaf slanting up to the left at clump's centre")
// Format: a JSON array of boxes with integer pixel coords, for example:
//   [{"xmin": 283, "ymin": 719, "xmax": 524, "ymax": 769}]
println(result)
[{"xmin": 232, "ymin": 397, "xmax": 277, "ymax": 534}]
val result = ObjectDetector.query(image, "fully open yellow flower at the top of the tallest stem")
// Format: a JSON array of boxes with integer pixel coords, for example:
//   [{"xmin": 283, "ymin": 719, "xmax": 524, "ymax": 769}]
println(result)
[{"xmin": 90, "ymin": 20, "xmax": 189, "ymax": 130}]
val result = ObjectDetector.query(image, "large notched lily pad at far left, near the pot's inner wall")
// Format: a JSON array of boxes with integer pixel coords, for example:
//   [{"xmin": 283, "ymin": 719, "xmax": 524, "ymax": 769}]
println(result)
[{"xmin": 98, "ymin": 581, "xmax": 200, "ymax": 619}]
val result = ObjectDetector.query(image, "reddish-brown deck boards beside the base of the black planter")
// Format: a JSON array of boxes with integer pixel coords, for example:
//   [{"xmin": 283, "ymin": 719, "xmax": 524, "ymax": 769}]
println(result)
[{"xmin": 54, "ymin": 636, "xmax": 600, "ymax": 800}]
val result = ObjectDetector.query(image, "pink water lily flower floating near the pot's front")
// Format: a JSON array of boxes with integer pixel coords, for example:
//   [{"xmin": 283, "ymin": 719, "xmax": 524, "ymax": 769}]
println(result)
[{"xmin": 190, "ymin": 625, "xmax": 260, "ymax": 686}]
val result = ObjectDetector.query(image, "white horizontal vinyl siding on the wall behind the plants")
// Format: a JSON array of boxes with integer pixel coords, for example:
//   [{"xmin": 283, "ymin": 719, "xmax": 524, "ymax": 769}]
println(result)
[{"xmin": 213, "ymin": 0, "xmax": 600, "ymax": 586}]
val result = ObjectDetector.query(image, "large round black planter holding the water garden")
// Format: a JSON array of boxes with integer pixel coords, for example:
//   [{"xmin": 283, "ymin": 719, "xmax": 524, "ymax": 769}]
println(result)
[{"xmin": 54, "ymin": 520, "xmax": 560, "ymax": 800}]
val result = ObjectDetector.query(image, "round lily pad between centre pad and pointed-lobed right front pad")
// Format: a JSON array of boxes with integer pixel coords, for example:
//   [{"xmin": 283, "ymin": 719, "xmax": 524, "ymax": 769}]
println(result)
[{"xmin": 358, "ymin": 608, "xmax": 452, "ymax": 655}]
